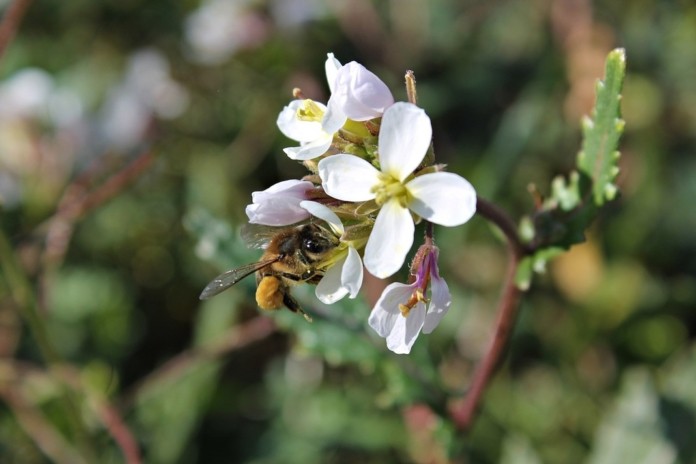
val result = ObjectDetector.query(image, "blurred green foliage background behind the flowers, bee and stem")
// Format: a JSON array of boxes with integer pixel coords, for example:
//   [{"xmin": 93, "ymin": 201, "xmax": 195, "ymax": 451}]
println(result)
[{"xmin": 0, "ymin": 0, "xmax": 696, "ymax": 464}]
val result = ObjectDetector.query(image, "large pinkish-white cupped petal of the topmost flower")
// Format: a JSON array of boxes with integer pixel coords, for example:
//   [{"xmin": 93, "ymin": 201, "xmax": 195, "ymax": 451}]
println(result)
[{"xmin": 331, "ymin": 61, "xmax": 394, "ymax": 121}]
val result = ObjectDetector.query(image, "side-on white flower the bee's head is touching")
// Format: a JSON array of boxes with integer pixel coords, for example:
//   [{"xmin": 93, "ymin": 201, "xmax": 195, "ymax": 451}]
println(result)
[{"xmin": 300, "ymin": 201, "xmax": 363, "ymax": 304}]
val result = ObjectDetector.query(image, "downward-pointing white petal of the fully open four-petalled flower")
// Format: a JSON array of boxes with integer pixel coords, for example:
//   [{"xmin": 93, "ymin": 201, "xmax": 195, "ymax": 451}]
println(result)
[{"xmin": 364, "ymin": 199, "xmax": 414, "ymax": 279}]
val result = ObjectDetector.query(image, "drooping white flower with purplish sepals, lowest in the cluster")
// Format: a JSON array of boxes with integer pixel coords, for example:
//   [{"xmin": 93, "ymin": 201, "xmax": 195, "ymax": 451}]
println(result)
[{"xmin": 368, "ymin": 247, "xmax": 452, "ymax": 354}]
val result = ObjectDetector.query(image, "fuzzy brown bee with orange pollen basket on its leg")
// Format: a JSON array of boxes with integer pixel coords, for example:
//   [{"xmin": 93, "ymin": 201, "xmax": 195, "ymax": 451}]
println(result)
[{"xmin": 200, "ymin": 223, "xmax": 340, "ymax": 322}]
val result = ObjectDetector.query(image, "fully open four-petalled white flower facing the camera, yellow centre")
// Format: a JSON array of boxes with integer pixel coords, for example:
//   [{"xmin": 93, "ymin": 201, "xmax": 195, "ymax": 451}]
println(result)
[{"xmin": 318, "ymin": 102, "xmax": 476, "ymax": 278}]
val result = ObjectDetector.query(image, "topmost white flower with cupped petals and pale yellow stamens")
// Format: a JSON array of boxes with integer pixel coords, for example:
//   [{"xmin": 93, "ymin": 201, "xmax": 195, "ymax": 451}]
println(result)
[{"xmin": 277, "ymin": 53, "xmax": 394, "ymax": 160}]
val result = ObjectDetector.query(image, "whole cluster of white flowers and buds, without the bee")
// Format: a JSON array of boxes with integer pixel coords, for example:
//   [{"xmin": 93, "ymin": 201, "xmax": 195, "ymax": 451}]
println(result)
[{"xmin": 246, "ymin": 54, "xmax": 476, "ymax": 353}]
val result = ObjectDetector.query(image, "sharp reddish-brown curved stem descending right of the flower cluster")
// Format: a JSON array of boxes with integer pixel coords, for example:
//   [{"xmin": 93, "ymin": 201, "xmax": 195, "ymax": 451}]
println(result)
[{"xmin": 451, "ymin": 194, "xmax": 525, "ymax": 430}]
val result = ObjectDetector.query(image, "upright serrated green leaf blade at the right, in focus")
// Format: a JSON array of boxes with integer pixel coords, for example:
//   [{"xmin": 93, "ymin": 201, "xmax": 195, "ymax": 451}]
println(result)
[{"xmin": 577, "ymin": 48, "xmax": 626, "ymax": 206}]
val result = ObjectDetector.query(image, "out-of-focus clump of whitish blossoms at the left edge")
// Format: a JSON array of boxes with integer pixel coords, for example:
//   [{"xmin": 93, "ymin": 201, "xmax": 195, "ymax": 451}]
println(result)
[{"xmin": 0, "ymin": 49, "xmax": 189, "ymax": 207}]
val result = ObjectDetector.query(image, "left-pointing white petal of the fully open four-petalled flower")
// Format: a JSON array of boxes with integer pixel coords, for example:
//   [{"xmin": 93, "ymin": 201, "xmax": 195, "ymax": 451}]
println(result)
[{"xmin": 318, "ymin": 154, "xmax": 379, "ymax": 201}]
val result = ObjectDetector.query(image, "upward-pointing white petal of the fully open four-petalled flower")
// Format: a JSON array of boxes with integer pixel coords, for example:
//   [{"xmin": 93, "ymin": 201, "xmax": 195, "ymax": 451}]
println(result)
[{"xmin": 379, "ymin": 102, "xmax": 433, "ymax": 181}]
